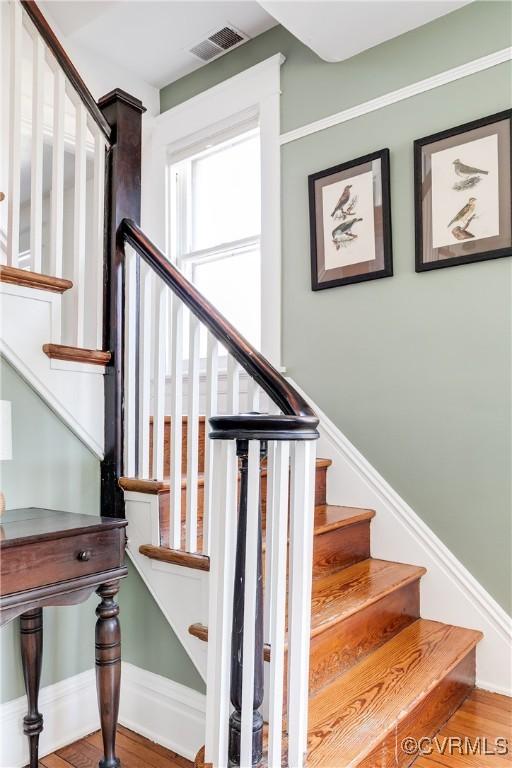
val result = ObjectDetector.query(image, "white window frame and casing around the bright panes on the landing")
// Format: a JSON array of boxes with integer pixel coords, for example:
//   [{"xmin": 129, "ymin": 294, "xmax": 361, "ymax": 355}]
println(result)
[{"xmin": 147, "ymin": 54, "xmax": 284, "ymax": 368}]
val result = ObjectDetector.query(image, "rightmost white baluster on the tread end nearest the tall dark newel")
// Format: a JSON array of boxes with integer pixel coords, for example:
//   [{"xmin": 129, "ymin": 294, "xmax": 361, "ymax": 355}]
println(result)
[{"xmin": 153, "ymin": 278, "xmax": 167, "ymax": 480}]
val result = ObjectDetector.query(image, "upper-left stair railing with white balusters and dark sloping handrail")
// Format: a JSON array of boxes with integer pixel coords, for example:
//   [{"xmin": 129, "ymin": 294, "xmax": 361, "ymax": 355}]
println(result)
[{"xmin": 0, "ymin": 0, "xmax": 111, "ymax": 349}]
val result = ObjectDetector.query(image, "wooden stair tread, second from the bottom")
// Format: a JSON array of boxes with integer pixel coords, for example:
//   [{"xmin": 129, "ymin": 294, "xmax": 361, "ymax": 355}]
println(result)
[{"xmin": 311, "ymin": 558, "xmax": 426, "ymax": 635}]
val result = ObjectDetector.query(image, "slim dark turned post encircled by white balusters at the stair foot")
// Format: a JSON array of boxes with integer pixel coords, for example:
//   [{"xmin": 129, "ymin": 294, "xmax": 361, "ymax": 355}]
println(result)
[{"xmin": 229, "ymin": 440, "xmax": 266, "ymax": 768}]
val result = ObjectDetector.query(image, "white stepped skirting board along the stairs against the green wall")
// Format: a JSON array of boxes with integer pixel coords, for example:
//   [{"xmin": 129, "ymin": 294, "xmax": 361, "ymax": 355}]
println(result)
[{"xmin": 290, "ymin": 379, "xmax": 512, "ymax": 696}]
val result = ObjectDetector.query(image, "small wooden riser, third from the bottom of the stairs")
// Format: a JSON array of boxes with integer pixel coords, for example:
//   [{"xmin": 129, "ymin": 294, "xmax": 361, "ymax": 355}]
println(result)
[{"xmin": 313, "ymin": 520, "xmax": 370, "ymax": 578}]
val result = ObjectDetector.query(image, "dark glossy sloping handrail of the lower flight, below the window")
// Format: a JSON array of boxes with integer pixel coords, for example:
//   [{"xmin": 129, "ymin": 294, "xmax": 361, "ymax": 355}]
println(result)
[{"xmin": 120, "ymin": 219, "xmax": 318, "ymax": 428}]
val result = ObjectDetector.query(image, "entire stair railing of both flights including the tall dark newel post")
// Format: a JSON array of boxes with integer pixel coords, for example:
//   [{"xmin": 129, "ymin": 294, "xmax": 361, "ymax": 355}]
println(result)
[{"xmin": 4, "ymin": 0, "xmax": 318, "ymax": 768}]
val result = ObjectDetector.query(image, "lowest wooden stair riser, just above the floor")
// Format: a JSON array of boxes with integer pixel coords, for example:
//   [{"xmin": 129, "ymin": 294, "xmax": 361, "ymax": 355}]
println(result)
[{"xmin": 356, "ymin": 649, "xmax": 476, "ymax": 768}]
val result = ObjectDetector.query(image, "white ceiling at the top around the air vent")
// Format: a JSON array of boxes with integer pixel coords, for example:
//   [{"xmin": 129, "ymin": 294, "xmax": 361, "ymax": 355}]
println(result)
[{"xmin": 42, "ymin": 0, "xmax": 470, "ymax": 88}]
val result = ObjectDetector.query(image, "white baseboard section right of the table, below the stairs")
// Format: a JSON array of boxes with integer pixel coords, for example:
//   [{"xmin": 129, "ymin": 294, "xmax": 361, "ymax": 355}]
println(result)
[{"xmin": 119, "ymin": 661, "xmax": 206, "ymax": 761}]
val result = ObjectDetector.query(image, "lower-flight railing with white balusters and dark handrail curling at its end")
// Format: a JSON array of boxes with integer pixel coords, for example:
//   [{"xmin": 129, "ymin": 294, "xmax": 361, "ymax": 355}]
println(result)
[{"xmin": 119, "ymin": 219, "xmax": 318, "ymax": 768}]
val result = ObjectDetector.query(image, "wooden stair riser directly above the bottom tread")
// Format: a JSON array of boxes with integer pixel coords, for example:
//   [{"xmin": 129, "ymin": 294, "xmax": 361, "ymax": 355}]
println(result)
[{"xmin": 309, "ymin": 579, "xmax": 420, "ymax": 694}]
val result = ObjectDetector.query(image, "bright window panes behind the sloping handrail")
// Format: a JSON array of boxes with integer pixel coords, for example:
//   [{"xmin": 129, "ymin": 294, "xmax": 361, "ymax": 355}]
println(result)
[{"xmin": 168, "ymin": 128, "xmax": 261, "ymax": 349}]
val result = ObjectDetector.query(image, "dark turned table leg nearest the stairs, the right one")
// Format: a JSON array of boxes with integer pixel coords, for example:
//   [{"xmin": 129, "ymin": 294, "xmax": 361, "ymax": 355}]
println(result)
[{"xmin": 96, "ymin": 581, "xmax": 121, "ymax": 768}]
